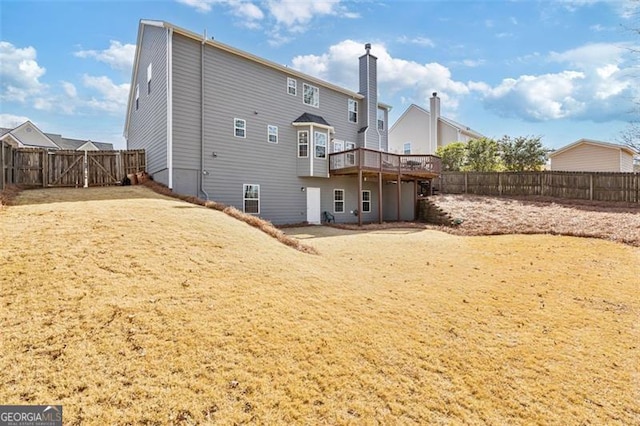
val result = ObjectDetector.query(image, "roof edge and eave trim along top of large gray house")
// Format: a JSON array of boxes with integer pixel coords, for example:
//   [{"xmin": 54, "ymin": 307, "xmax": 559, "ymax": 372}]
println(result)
[{"xmin": 124, "ymin": 19, "xmax": 392, "ymax": 137}]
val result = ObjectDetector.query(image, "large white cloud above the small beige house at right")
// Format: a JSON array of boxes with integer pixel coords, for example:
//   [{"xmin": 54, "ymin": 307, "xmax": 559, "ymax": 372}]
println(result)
[{"xmin": 469, "ymin": 43, "xmax": 640, "ymax": 121}]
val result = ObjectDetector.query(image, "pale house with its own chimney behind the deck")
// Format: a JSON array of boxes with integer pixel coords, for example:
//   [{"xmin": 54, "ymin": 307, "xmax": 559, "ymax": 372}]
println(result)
[{"xmin": 389, "ymin": 92, "xmax": 484, "ymax": 154}]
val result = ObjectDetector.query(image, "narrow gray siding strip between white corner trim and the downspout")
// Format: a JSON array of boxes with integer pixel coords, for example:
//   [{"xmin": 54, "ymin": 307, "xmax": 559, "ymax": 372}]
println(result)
[{"xmin": 172, "ymin": 34, "xmax": 201, "ymax": 195}]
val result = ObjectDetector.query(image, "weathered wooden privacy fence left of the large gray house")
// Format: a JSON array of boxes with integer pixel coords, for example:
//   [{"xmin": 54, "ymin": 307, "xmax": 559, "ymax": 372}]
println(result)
[{"xmin": 0, "ymin": 143, "xmax": 146, "ymax": 190}]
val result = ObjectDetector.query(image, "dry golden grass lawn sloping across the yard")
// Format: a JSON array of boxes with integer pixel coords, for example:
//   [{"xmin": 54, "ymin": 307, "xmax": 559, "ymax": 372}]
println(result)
[{"xmin": 0, "ymin": 186, "xmax": 640, "ymax": 425}]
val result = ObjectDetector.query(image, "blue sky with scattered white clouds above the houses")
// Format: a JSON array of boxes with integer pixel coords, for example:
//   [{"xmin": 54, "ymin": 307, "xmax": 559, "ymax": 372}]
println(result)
[{"xmin": 0, "ymin": 0, "xmax": 640, "ymax": 149}]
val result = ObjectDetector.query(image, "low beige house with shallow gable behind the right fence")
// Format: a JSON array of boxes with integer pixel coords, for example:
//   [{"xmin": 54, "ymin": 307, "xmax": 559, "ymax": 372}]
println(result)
[{"xmin": 549, "ymin": 139, "xmax": 638, "ymax": 172}]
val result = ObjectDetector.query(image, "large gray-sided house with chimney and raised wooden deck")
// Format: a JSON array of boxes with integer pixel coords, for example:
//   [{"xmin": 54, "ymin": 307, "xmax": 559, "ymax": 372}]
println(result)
[{"xmin": 124, "ymin": 20, "xmax": 439, "ymax": 224}]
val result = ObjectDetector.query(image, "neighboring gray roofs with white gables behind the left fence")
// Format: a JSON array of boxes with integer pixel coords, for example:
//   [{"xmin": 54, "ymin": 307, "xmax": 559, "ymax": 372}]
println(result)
[{"xmin": 0, "ymin": 120, "xmax": 113, "ymax": 151}]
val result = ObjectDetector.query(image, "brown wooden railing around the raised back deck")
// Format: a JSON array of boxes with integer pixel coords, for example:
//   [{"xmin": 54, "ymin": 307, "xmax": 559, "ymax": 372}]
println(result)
[{"xmin": 329, "ymin": 148, "xmax": 442, "ymax": 175}]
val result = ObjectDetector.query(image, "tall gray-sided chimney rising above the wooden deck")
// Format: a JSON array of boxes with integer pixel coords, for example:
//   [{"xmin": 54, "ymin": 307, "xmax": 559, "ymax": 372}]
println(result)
[{"xmin": 358, "ymin": 43, "xmax": 382, "ymax": 150}]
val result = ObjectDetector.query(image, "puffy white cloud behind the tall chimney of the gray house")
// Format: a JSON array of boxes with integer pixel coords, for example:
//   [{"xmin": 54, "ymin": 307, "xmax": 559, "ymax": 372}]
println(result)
[{"xmin": 292, "ymin": 40, "xmax": 469, "ymax": 112}]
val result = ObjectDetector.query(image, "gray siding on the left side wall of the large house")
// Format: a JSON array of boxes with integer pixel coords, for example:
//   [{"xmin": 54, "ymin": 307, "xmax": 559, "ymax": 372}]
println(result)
[{"xmin": 127, "ymin": 26, "xmax": 167, "ymax": 178}]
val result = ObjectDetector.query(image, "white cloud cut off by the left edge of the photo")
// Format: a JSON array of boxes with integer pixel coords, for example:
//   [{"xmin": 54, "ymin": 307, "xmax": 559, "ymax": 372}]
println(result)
[{"xmin": 0, "ymin": 41, "xmax": 46, "ymax": 102}]
